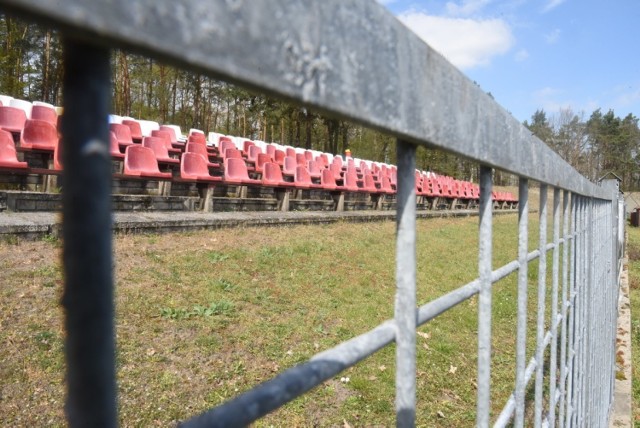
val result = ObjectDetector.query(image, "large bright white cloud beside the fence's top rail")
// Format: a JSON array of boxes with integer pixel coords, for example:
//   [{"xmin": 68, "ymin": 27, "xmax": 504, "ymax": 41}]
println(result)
[{"xmin": 398, "ymin": 12, "xmax": 514, "ymax": 69}]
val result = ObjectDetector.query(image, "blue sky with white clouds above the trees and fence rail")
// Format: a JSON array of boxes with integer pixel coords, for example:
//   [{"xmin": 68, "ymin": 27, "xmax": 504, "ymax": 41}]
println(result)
[{"xmin": 378, "ymin": 0, "xmax": 640, "ymax": 122}]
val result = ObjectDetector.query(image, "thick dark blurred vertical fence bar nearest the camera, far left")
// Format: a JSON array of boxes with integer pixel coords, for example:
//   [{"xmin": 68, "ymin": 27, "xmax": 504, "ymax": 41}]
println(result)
[{"xmin": 62, "ymin": 38, "xmax": 117, "ymax": 427}]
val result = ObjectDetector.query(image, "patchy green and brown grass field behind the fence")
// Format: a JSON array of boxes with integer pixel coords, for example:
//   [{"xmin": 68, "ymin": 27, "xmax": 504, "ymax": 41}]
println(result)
[{"xmin": 0, "ymin": 214, "xmax": 576, "ymax": 426}]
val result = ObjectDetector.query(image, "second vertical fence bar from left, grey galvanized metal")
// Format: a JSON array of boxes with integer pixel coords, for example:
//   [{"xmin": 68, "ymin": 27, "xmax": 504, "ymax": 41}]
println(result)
[{"xmin": 395, "ymin": 140, "xmax": 417, "ymax": 427}]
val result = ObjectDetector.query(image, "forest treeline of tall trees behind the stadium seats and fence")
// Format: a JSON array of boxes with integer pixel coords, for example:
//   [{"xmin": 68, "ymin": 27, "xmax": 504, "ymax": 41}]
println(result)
[{"xmin": 0, "ymin": 14, "xmax": 640, "ymax": 190}]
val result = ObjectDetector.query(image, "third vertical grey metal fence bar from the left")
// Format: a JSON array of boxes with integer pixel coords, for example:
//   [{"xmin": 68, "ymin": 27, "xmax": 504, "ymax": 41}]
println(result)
[{"xmin": 476, "ymin": 166, "xmax": 493, "ymax": 428}]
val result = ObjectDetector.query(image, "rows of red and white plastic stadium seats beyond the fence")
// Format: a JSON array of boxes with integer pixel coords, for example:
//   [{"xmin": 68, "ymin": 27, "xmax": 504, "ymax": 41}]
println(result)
[{"xmin": 0, "ymin": 96, "xmax": 517, "ymax": 211}]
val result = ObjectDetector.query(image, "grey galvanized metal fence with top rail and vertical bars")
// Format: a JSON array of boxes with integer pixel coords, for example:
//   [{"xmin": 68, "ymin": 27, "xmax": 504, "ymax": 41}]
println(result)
[{"xmin": 2, "ymin": 0, "xmax": 623, "ymax": 427}]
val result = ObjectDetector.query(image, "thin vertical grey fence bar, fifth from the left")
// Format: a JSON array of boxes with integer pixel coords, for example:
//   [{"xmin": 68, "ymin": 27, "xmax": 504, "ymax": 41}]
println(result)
[{"xmin": 534, "ymin": 184, "xmax": 547, "ymax": 428}]
